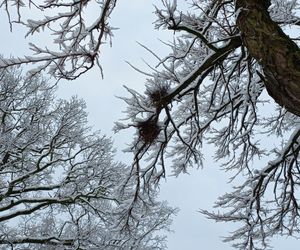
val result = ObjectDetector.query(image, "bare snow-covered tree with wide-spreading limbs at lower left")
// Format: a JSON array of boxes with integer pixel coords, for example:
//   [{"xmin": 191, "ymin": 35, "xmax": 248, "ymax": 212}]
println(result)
[{"xmin": 0, "ymin": 68, "xmax": 175, "ymax": 250}]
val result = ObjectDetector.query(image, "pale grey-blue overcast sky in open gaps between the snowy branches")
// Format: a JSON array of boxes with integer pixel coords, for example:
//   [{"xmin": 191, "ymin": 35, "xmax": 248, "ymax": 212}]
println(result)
[{"xmin": 1, "ymin": 0, "xmax": 298, "ymax": 250}]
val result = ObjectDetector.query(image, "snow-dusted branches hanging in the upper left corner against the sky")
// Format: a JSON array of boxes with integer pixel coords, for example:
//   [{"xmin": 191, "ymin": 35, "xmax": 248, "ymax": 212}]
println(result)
[{"xmin": 0, "ymin": 0, "xmax": 116, "ymax": 80}]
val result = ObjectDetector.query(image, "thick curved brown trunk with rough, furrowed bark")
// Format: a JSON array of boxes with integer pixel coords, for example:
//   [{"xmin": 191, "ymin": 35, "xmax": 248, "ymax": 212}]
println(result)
[{"xmin": 236, "ymin": 0, "xmax": 300, "ymax": 116}]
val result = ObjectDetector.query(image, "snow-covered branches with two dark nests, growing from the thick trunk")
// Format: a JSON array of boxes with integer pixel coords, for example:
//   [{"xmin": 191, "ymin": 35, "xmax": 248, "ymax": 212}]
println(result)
[{"xmin": 116, "ymin": 0, "xmax": 300, "ymax": 250}]
